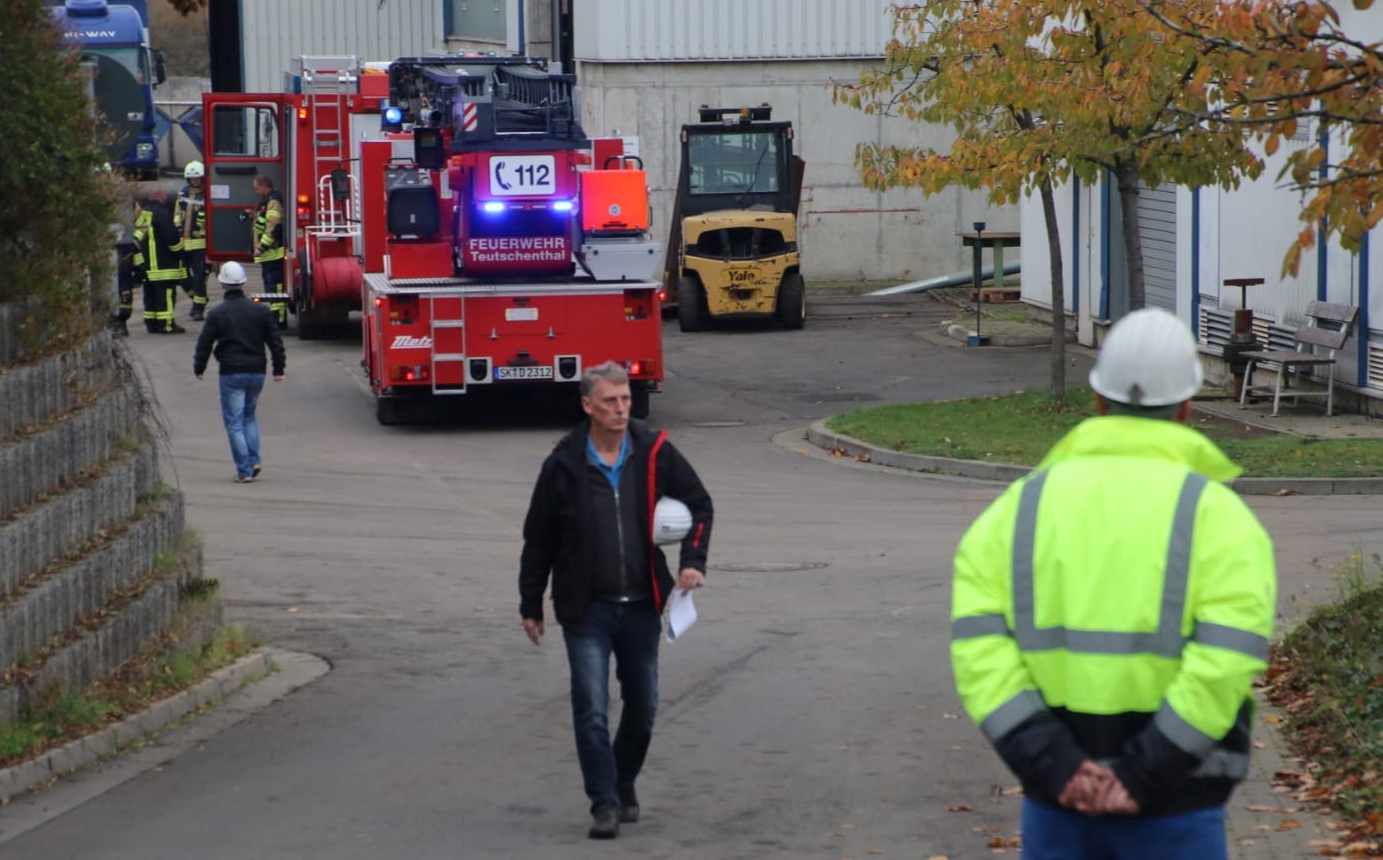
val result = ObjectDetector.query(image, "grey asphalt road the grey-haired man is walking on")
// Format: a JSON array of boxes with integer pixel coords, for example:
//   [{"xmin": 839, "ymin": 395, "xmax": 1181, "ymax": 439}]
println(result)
[{"xmin": 0, "ymin": 296, "xmax": 1383, "ymax": 860}]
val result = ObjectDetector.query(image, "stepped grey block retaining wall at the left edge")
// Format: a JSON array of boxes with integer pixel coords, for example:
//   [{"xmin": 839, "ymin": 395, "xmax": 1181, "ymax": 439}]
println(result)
[{"xmin": 0, "ymin": 320, "xmax": 220, "ymax": 726}]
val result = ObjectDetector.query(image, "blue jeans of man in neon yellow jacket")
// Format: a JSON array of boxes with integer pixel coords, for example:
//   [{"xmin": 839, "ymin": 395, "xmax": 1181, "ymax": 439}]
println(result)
[{"xmin": 1022, "ymin": 801, "xmax": 1228, "ymax": 860}]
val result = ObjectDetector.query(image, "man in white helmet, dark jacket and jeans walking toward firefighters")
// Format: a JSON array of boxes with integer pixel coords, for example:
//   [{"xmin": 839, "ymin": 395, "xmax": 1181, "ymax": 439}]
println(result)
[{"xmin": 192, "ymin": 261, "xmax": 285, "ymax": 484}]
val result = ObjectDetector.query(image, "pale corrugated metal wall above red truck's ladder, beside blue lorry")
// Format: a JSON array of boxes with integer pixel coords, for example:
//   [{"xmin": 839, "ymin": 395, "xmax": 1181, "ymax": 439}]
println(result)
[{"xmin": 240, "ymin": 0, "xmax": 445, "ymax": 93}]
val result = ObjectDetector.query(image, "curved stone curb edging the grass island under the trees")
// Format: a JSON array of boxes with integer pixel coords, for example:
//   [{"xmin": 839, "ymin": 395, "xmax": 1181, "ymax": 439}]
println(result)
[{"xmin": 806, "ymin": 419, "xmax": 1383, "ymax": 496}]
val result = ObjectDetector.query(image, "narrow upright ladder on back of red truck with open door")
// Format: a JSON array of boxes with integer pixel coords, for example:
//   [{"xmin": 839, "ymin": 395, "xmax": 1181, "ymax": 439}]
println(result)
[{"xmin": 299, "ymin": 57, "xmax": 361, "ymax": 239}]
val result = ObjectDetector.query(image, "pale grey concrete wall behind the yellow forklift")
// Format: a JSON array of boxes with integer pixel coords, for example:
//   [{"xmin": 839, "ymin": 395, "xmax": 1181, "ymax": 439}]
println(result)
[{"xmin": 577, "ymin": 60, "xmax": 1018, "ymax": 282}]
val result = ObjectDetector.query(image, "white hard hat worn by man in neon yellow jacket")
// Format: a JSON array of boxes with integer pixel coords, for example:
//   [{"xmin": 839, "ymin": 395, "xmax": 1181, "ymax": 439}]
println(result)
[{"xmin": 1090, "ymin": 307, "xmax": 1205, "ymax": 406}]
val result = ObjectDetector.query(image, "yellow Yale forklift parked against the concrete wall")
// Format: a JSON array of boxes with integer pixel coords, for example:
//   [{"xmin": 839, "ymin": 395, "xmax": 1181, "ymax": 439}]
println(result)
[{"xmin": 664, "ymin": 104, "xmax": 806, "ymax": 332}]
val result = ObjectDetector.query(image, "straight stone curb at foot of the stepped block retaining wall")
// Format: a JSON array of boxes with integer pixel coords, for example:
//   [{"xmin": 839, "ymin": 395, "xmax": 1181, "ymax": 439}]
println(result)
[{"xmin": 0, "ymin": 648, "xmax": 325, "ymax": 807}]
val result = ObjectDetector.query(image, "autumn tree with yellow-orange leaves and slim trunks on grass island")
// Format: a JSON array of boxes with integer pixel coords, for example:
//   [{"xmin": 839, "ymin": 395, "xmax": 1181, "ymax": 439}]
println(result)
[{"xmin": 835, "ymin": 0, "xmax": 1263, "ymax": 395}]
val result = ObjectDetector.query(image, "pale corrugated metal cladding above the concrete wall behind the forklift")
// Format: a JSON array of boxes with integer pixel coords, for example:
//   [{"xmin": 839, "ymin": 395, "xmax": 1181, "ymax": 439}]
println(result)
[{"xmin": 575, "ymin": 0, "xmax": 896, "ymax": 62}]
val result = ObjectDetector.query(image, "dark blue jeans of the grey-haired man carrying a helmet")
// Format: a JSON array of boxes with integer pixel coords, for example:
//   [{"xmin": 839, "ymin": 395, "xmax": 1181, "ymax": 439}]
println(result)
[{"xmin": 561, "ymin": 600, "xmax": 662, "ymax": 814}]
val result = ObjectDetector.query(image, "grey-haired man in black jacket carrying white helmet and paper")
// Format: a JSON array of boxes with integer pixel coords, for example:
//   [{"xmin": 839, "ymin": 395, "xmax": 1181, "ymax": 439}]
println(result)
[{"xmin": 519, "ymin": 362, "xmax": 712, "ymax": 839}]
